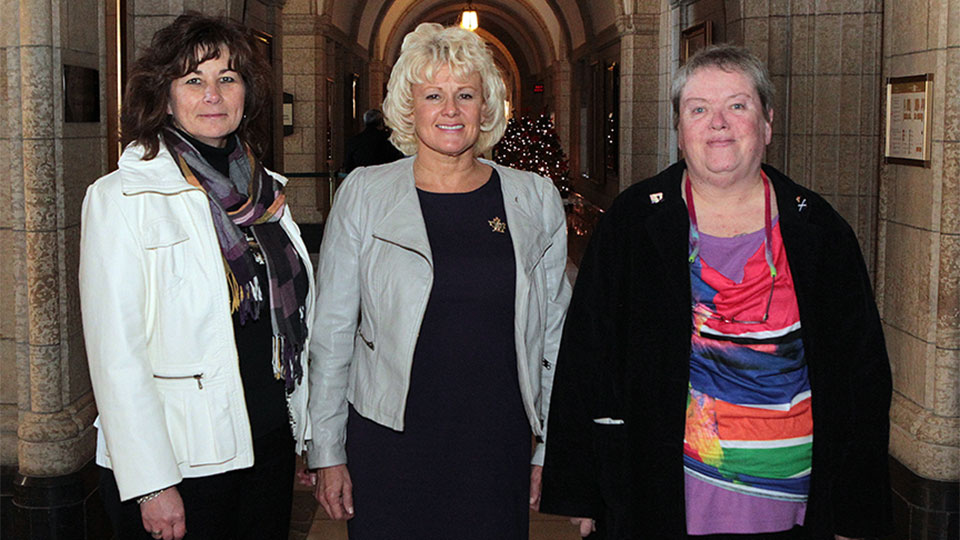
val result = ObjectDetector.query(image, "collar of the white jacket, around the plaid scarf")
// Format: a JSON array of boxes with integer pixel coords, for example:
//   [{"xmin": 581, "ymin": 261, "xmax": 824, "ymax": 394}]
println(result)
[{"xmin": 117, "ymin": 141, "xmax": 287, "ymax": 195}]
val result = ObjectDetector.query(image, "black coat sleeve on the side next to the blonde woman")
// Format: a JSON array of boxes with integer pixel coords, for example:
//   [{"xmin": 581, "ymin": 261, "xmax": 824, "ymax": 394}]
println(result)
[{"xmin": 541, "ymin": 204, "xmax": 622, "ymax": 518}]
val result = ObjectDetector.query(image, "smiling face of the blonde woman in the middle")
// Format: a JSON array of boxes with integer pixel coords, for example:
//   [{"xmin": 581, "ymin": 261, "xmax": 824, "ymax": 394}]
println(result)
[{"xmin": 413, "ymin": 67, "xmax": 483, "ymax": 159}]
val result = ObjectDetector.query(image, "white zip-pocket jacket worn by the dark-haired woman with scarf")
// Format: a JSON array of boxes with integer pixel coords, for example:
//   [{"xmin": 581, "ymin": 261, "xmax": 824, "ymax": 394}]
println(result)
[{"xmin": 80, "ymin": 141, "xmax": 314, "ymax": 500}]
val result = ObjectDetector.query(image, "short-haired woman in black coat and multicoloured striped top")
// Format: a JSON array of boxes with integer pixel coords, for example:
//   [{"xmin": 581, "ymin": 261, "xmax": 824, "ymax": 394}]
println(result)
[{"xmin": 541, "ymin": 46, "xmax": 891, "ymax": 540}]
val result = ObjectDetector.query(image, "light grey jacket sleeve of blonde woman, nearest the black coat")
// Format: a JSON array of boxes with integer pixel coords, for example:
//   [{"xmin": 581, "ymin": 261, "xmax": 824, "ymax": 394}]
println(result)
[{"xmin": 533, "ymin": 179, "xmax": 571, "ymax": 465}]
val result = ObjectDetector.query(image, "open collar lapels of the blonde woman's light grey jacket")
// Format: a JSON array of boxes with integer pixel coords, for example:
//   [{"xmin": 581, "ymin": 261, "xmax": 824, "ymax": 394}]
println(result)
[{"xmin": 373, "ymin": 157, "xmax": 550, "ymax": 270}]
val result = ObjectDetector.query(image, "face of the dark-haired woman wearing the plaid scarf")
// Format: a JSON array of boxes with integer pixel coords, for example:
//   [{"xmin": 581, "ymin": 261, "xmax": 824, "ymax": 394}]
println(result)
[{"xmin": 167, "ymin": 49, "xmax": 246, "ymax": 147}]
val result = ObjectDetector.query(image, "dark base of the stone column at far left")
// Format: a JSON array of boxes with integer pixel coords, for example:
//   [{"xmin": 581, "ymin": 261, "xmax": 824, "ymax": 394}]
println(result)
[{"xmin": 0, "ymin": 460, "xmax": 112, "ymax": 540}]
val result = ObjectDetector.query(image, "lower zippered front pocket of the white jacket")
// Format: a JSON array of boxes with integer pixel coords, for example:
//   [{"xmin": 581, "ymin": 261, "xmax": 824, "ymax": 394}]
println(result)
[{"xmin": 158, "ymin": 382, "xmax": 237, "ymax": 466}]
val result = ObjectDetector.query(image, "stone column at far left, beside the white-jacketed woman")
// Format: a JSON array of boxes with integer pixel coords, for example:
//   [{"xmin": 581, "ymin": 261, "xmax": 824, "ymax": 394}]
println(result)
[{"xmin": 0, "ymin": 0, "xmax": 105, "ymax": 538}]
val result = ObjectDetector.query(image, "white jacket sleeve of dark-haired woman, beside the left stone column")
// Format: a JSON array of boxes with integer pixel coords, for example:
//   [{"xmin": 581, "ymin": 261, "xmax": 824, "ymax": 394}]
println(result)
[{"xmin": 79, "ymin": 177, "xmax": 182, "ymax": 500}]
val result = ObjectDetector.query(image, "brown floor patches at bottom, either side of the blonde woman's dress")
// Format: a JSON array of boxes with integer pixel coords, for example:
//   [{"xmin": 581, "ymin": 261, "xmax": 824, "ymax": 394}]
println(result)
[{"xmin": 290, "ymin": 460, "xmax": 580, "ymax": 540}]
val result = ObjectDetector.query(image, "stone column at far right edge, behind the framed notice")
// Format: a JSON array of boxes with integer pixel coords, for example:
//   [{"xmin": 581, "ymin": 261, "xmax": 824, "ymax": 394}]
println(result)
[{"xmin": 876, "ymin": 0, "xmax": 960, "ymax": 539}]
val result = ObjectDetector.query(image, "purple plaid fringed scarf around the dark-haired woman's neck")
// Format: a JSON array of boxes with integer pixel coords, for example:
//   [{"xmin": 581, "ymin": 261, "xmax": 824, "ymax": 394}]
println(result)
[{"xmin": 163, "ymin": 128, "xmax": 309, "ymax": 392}]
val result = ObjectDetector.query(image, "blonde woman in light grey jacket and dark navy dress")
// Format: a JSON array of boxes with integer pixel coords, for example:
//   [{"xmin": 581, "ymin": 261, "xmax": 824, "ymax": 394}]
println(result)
[{"xmin": 308, "ymin": 23, "xmax": 570, "ymax": 540}]
